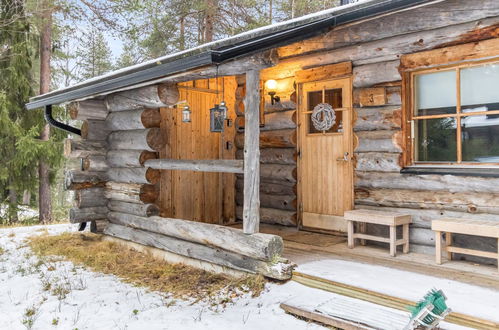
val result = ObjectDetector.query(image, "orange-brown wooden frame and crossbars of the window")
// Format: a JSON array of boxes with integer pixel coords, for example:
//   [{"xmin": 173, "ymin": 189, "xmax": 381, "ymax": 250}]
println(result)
[{"xmin": 408, "ymin": 58, "xmax": 499, "ymax": 167}]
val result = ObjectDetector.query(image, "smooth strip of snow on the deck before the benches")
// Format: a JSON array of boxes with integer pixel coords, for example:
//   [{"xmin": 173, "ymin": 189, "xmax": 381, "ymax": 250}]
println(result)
[{"xmin": 296, "ymin": 260, "xmax": 499, "ymax": 322}]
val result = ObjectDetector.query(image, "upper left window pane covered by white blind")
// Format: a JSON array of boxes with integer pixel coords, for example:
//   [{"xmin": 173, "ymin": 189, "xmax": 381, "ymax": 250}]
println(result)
[{"xmin": 414, "ymin": 70, "xmax": 457, "ymax": 116}]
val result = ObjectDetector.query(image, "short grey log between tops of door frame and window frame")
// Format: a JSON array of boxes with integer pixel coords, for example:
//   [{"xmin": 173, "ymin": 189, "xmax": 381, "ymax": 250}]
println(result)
[{"xmin": 353, "ymin": 60, "xmax": 402, "ymax": 87}]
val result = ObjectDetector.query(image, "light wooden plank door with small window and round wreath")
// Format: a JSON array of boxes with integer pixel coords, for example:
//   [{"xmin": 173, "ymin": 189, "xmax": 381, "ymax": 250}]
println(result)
[{"xmin": 298, "ymin": 78, "xmax": 353, "ymax": 231}]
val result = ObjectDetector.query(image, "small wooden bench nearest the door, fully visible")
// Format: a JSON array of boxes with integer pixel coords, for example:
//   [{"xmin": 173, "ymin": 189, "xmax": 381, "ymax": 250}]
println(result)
[{"xmin": 344, "ymin": 210, "xmax": 412, "ymax": 257}]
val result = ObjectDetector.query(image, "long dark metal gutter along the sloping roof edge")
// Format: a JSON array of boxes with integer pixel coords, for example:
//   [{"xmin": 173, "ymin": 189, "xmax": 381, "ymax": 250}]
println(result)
[{"xmin": 26, "ymin": 0, "xmax": 435, "ymax": 110}]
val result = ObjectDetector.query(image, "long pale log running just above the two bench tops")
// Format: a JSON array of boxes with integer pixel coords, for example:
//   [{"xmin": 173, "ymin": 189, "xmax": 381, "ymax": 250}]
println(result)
[{"xmin": 355, "ymin": 188, "xmax": 499, "ymax": 215}]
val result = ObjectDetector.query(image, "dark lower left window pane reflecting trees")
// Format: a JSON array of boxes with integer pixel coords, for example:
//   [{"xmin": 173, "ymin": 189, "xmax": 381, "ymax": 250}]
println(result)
[{"xmin": 416, "ymin": 118, "xmax": 457, "ymax": 162}]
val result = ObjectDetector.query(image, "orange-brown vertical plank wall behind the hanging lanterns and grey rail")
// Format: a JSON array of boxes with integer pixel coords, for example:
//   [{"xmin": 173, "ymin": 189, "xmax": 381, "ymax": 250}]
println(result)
[{"xmin": 160, "ymin": 78, "xmax": 235, "ymax": 224}]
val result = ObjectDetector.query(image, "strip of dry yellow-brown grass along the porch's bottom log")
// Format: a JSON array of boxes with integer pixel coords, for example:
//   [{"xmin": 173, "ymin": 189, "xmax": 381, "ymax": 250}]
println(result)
[{"xmin": 29, "ymin": 233, "xmax": 265, "ymax": 299}]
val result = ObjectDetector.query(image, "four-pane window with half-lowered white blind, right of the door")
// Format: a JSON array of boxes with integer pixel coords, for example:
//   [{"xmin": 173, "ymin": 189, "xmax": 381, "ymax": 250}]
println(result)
[{"xmin": 411, "ymin": 63, "xmax": 499, "ymax": 164}]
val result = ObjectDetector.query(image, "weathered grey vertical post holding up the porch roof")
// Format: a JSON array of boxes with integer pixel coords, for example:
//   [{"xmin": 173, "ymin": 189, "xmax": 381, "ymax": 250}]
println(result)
[{"xmin": 243, "ymin": 70, "xmax": 260, "ymax": 234}]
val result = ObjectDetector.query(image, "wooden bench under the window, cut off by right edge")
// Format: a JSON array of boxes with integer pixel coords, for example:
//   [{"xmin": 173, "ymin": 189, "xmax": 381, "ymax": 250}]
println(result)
[{"xmin": 431, "ymin": 218, "xmax": 499, "ymax": 268}]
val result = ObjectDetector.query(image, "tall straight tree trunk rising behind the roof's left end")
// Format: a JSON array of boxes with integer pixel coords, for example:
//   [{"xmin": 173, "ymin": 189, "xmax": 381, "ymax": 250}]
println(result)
[{"xmin": 38, "ymin": 1, "xmax": 52, "ymax": 223}]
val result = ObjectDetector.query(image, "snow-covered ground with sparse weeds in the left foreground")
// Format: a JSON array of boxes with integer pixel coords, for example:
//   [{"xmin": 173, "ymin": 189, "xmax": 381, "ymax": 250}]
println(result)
[{"xmin": 0, "ymin": 225, "xmax": 321, "ymax": 330}]
